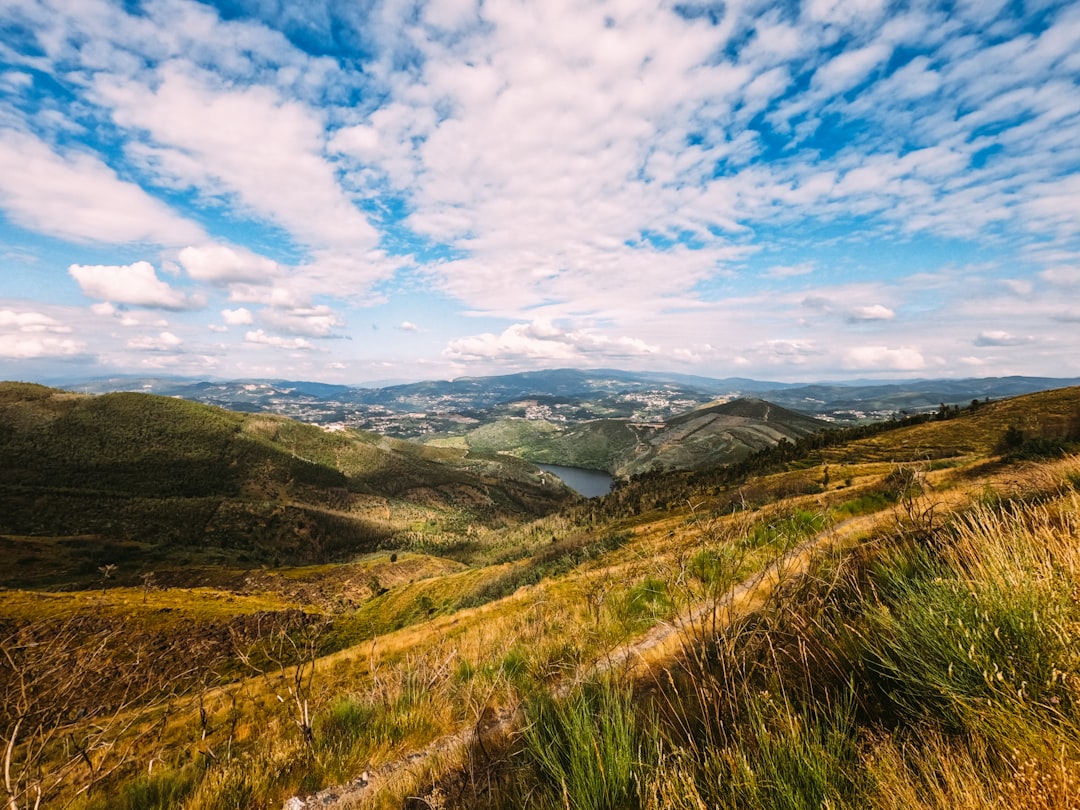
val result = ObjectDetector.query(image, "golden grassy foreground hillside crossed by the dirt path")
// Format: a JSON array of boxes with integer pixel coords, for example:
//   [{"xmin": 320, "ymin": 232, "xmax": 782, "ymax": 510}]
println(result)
[{"xmin": 0, "ymin": 389, "xmax": 1080, "ymax": 810}]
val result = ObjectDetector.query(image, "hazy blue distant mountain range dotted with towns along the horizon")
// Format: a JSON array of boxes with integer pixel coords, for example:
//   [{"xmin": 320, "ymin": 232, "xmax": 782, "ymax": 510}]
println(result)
[{"xmin": 57, "ymin": 368, "xmax": 1080, "ymax": 427}]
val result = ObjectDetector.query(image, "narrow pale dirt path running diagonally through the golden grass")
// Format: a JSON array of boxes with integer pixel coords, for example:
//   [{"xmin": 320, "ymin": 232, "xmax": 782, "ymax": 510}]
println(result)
[{"xmin": 284, "ymin": 513, "xmax": 883, "ymax": 810}]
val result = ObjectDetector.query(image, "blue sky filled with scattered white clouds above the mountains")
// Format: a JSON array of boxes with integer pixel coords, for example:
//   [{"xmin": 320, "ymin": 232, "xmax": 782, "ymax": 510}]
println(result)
[{"xmin": 0, "ymin": 0, "xmax": 1080, "ymax": 384}]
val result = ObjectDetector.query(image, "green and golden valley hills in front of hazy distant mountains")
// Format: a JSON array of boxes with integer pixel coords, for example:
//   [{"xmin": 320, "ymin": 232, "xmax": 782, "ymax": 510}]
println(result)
[{"xmin": 0, "ymin": 383, "xmax": 1080, "ymax": 810}]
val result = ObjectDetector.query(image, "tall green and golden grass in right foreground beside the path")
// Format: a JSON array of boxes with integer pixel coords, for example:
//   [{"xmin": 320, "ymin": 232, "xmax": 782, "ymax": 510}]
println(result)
[{"xmin": 574, "ymin": 475, "xmax": 1080, "ymax": 810}]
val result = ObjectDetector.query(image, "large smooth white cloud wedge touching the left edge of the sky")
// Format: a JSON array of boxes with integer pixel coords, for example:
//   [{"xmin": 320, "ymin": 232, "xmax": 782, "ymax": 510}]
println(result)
[{"xmin": 0, "ymin": 127, "xmax": 203, "ymax": 245}]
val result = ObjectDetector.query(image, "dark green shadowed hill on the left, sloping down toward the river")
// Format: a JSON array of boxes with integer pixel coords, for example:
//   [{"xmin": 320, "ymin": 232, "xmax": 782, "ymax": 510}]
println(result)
[{"xmin": 0, "ymin": 383, "xmax": 575, "ymax": 569}]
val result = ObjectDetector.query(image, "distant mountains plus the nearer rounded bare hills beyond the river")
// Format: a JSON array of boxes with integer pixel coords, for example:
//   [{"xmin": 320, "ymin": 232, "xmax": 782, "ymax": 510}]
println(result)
[{"xmin": 35, "ymin": 368, "xmax": 1080, "ymax": 477}]
